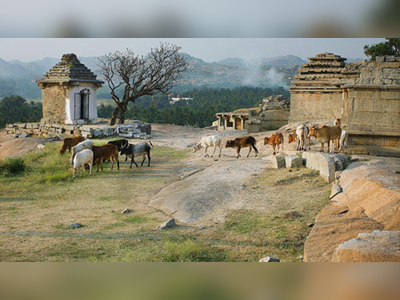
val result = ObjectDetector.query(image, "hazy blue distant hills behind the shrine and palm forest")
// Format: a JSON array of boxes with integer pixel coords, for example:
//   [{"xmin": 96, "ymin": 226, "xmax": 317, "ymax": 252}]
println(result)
[{"xmin": 0, "ymin": 53, "xmax": 305, "ymax": 99}]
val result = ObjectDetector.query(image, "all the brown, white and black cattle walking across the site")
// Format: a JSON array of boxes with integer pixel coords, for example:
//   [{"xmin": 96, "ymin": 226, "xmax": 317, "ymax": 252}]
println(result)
[{"xmin": 60, "ymin": 119, "xmax": 348, "ymax": 178}]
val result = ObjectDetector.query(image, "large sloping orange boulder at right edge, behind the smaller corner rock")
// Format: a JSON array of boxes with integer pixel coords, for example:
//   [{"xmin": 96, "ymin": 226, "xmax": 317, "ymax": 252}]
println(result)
[{"xmin": 304, "ymin": 156, "xmax": 400, "ymax": 261}]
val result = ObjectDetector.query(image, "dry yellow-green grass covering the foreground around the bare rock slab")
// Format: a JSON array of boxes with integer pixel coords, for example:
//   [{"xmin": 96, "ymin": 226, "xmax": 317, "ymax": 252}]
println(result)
[{"xmin": 0, "ymin": 141, "xmax": 329, "ymax": 261}]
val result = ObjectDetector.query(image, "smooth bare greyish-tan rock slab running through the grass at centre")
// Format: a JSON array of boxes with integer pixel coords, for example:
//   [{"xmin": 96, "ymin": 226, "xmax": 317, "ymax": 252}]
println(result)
[{"xmin": 145, "ymin": 125, "xmax": 294, "ymax": 224}]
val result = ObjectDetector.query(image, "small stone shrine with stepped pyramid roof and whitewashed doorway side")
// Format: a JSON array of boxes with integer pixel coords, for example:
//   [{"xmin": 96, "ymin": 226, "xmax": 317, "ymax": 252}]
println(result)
[{"xmin": 37, "ymin": 53, "xmax": 104, "ymax": 125}]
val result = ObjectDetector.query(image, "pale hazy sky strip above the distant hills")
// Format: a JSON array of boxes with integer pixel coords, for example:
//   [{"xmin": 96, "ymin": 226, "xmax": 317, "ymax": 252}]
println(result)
[{"xmin": 0, "ymin": 38, "xmax": 384, "ymax": 62}]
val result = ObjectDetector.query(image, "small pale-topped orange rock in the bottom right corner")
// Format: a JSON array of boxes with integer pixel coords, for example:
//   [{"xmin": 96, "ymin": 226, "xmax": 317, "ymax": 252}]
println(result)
[{"xmin": 332, "ymin": 230, "xmax": 400, "ymax": 262}]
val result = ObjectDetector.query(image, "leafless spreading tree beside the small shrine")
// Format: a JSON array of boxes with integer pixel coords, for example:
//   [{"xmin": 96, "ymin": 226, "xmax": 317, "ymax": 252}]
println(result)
[{"xmin": 99, "ymin": 43, "xmax": 188, "ymax": 125}]
